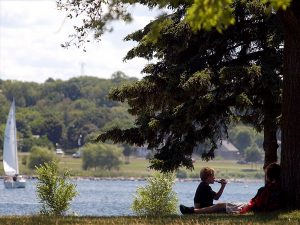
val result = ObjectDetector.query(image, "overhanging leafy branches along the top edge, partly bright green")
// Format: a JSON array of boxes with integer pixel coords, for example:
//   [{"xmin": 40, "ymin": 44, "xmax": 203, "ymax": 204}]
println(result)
[{"xmin": 57, "ymin": 0, "xmax": 291, "ymax": 48}]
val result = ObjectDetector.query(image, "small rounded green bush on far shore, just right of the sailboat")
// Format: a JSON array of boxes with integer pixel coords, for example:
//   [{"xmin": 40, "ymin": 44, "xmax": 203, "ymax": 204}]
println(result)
[{"xmin": 28, "ymin": 147, "xmax": 57, "ymax": 169}]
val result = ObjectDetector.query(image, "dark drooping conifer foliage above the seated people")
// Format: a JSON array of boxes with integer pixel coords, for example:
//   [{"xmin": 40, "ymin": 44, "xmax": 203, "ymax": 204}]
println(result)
[{"xmin": 98, "ymin": 1, "xmax": 283, "ymax": 171}]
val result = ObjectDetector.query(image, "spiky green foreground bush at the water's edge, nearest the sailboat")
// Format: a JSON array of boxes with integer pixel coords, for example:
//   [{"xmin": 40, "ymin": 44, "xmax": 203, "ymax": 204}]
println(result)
[{"xmin": 36, "ymin": 162, "xmax": 77, "ymax": 216}]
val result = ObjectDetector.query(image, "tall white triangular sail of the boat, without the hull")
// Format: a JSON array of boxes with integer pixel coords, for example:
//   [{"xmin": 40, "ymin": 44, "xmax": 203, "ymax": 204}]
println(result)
[{"xmin": 3, "ymin": 101, "xmax": 19, "ymax": 176}]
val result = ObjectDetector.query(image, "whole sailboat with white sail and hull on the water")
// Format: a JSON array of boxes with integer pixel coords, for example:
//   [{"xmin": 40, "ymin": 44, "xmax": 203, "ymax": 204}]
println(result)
[{"xmin": 3, "ymin": 100, "xmax": 26, "ymax": 188}]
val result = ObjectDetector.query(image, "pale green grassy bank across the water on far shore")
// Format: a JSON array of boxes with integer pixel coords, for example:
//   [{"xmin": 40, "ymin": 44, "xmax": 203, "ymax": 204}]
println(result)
[{"xmin": 0, "ymin": 153, "xmax": 263, "ymax": 179}]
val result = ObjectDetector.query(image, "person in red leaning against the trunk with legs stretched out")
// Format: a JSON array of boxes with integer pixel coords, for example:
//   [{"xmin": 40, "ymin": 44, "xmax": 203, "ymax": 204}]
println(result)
[{"xmin": 180, "ymin": 163, "xmax": 284, "ymax": 214}]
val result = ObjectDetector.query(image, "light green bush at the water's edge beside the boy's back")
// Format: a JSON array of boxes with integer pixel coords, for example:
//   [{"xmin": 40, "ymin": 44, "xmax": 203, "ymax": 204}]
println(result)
[{"xmin": 132, "ymin": 173, "xmax": 178, "ymax": 216}]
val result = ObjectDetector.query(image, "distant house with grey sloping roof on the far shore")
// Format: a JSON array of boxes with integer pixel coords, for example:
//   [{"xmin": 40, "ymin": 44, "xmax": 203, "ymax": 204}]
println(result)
[{"xmin": 215, "ymin": 140, "xmax": 240, "ymax": 160}]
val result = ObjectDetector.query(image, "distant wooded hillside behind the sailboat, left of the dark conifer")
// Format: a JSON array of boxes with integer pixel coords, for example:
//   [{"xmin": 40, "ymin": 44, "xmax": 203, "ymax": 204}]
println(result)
[{"xmin": 0, "ymin": 71, "xmax": 137, "ymax": 152}]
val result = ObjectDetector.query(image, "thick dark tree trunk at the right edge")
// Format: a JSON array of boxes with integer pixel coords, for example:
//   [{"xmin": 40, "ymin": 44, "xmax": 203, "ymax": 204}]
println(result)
[{"xmin": 279, "ymin": 0, "xmax": 300, "ymax": 208}]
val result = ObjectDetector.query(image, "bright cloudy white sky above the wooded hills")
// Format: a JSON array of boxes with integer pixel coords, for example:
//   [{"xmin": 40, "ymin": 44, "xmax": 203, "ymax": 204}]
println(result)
[{"xmin": 0, "ymin": 0, "xmax": 158, "ymax": 83}]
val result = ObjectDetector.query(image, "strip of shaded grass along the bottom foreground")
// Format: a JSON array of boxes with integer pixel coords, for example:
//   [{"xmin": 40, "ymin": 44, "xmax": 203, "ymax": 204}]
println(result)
[{"xmin": 0, "ymin": 211, "xmax": 300, "ymax": 225}]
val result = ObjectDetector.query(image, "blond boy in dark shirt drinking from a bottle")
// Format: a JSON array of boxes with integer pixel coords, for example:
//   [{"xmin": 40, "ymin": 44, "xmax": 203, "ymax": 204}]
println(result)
[{"xmin": 180, "ymin": 167, "xmax": 227, "ymax": 214}]
